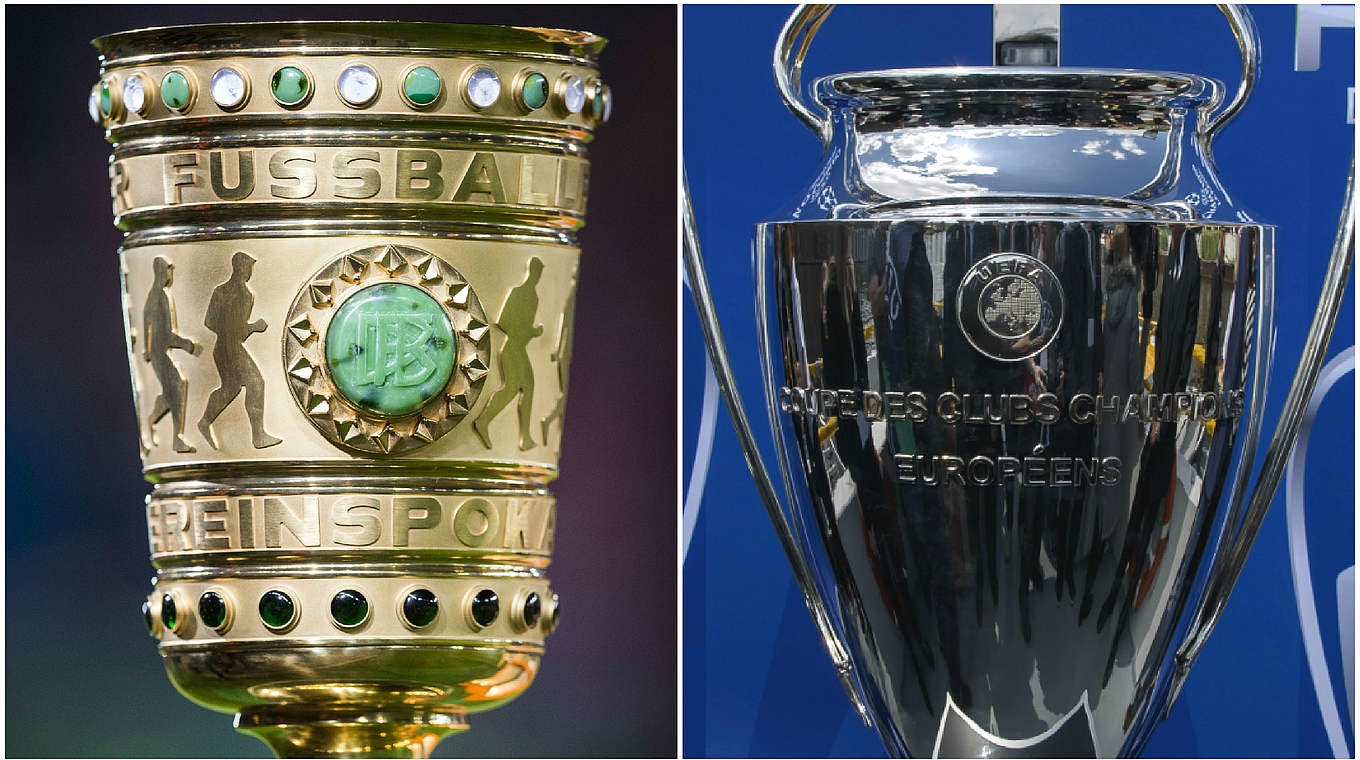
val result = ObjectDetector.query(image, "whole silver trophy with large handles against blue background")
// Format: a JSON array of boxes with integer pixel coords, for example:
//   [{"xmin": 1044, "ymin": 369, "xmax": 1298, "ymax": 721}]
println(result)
[{"xmin": 685, "ymin": 5, "xmax": 1353, "ymax": 757}]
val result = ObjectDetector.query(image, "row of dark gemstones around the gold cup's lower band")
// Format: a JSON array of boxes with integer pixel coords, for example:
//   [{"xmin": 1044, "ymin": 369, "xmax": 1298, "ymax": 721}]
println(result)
[{"xmin": 141, "ymin": 589, "xmax": 558, "ymax": 635}]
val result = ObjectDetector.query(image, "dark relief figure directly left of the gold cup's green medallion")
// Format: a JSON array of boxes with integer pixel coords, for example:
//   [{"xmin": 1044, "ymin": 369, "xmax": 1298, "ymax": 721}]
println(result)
[{"xmin": 199, "ymin": 250, "xmax": 283, "ymax": 449}]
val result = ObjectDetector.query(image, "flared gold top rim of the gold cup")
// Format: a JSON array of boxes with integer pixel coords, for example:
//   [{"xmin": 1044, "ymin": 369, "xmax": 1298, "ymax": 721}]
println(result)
[{"xmin": 90, "ymin": 20, "xmax": 607, "ymax": 65}]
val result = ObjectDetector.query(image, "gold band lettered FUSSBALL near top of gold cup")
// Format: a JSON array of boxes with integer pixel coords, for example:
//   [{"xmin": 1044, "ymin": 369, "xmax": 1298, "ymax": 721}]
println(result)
[{"xmin": 109, "ymin": 145, "xmax": 588, "ymax": 220}]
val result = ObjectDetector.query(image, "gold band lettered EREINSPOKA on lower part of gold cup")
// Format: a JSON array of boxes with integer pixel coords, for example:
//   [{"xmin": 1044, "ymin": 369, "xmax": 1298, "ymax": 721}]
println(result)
[{"xmin": 147, "ymin": 492, "xmax": 556, "ymax": 567}]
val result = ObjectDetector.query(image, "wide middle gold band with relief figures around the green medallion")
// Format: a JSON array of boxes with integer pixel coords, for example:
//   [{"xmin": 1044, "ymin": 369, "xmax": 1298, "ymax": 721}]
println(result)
[{"xmin": 122, "ymin": 237, "xmax": 579, "ymax": 483}]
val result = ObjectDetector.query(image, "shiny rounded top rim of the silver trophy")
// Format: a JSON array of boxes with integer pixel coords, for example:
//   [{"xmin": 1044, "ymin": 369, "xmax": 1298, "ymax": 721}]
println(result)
[{"xmin": 813, "ymin": 67, "xmax": 1223, "ymax": 102}]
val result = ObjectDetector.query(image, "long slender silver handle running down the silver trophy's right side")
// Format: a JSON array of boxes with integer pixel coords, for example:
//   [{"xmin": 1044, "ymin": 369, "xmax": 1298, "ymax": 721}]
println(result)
[{"xmin": 1163, "ymin": 152, "xmax": 1356, "ymax": 718}]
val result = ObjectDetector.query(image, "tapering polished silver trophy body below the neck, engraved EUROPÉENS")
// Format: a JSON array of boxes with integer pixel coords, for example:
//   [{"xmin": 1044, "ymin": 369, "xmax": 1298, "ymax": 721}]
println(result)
[{"xmin": 758, "ymin": 219, "xmax": 1272, "ymax": 757}]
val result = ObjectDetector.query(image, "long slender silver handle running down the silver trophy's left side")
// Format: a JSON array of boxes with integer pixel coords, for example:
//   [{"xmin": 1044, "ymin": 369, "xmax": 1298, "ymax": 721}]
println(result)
[{"xmin": 680, "ymin": 175, "xmax": 872, "ymax": 727}]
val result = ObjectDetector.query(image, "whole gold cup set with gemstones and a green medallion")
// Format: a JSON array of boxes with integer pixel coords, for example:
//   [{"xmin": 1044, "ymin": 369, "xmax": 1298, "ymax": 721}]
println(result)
[{"xmin": 90, "ymin": 22, "xmax": 611, "ymax": 757}]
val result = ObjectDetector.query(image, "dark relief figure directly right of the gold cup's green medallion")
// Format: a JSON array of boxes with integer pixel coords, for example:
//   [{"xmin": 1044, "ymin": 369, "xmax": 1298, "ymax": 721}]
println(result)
[{"xmin": 472, "ymin": 258, "xmax": 543, "ymax": 451}]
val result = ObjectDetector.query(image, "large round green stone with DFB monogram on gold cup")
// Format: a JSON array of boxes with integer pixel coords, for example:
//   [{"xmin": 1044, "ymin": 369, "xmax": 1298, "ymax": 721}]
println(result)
[{"xmin": 326, "ymin": 283, "xmax": 458, "ymax": 417}]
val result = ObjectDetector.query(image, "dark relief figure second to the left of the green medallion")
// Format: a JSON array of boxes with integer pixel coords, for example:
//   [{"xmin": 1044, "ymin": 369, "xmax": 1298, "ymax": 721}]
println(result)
[{"xmin": 141, "ymin": 256, "xmax": 203, "ymax": 454}]
